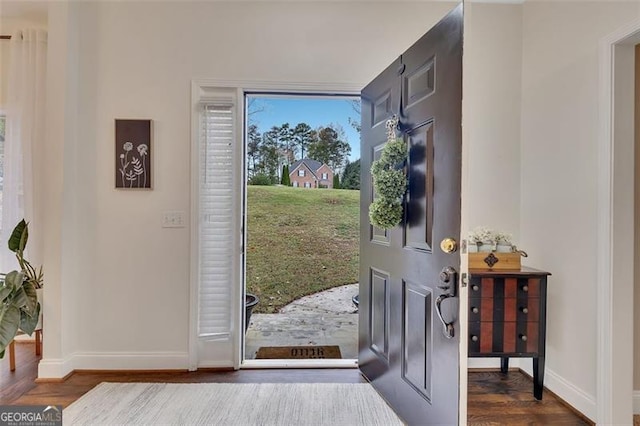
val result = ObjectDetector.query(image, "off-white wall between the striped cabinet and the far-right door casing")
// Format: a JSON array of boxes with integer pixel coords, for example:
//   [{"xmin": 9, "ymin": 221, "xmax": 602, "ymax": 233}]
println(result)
[{"xmin": 520, "ymin": 2, "xmax": 640, "ymax": 418}]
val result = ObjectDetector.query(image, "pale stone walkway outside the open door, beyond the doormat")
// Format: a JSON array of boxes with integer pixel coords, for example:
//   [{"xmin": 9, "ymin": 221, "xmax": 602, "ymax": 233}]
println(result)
[{"xmin": 245, "ymin": 284, "xmax": 358, "ymax": 359}]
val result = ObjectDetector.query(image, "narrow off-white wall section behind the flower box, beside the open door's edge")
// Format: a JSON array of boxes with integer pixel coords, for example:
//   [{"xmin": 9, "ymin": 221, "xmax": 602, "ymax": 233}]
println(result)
[{"xmin": 462, "ymin": 2, "xmax": 522, "ymax": 368}]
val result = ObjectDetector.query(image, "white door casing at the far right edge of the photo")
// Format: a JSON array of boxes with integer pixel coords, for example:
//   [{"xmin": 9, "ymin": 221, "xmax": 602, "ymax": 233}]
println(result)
[{"xmin": 596, "ymin": 20, "xmax": 640, "ymax": 424}]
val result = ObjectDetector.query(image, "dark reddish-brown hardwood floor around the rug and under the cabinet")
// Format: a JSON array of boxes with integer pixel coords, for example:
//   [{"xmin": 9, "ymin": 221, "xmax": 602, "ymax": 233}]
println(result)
[{"xmin": 0, "ymin": 343, "xmax": 593, "ymax": 426}]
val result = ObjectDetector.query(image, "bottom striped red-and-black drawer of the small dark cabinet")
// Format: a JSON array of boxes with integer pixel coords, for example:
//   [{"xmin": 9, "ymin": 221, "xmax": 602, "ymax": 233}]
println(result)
[{"xmin": 469, "ymin": 321, "xmax": 539, "ymax": 355}]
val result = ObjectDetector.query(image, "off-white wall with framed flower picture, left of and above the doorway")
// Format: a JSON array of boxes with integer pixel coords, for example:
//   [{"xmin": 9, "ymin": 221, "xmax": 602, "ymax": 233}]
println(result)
[{"xmin": 40, "ymin": 2, "xmax": 450, "ymax": 377}]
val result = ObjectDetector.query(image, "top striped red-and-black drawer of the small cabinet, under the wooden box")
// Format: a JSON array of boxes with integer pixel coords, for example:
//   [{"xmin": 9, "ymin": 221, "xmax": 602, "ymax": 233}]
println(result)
[{"xmin": 469, "ymin": 277, "xmax": 540, "ymax": 299}]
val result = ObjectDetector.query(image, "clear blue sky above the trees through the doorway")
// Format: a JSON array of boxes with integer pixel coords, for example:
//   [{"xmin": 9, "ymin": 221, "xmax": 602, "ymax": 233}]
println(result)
[{"xmin": 247, "ymin": 96, "xmax": 360, "ymax": 161}]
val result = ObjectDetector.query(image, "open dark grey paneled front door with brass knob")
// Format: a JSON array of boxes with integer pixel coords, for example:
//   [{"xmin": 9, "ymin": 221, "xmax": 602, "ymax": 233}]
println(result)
[{"xmin": 358, "ymin": 6, "xmax": 462, "ymax": 425}]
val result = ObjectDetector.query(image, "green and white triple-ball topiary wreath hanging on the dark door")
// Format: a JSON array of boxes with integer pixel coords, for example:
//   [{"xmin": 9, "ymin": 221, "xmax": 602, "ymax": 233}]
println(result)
[{"xmin": 369, "ymin": 115, "xmax": 408, "ymax": 229}]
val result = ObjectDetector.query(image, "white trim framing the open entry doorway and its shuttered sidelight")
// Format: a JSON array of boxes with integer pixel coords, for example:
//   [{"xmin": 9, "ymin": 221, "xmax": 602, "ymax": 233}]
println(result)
[{"xmin": 188, "ymin": 79, "xmax": 365, "ymax": 371}]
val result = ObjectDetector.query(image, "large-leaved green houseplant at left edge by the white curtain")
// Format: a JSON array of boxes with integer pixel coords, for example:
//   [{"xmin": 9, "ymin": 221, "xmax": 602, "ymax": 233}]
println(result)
[{"xmin": 0, "ymin": 219, "xmax": 43, "ymax": 358}]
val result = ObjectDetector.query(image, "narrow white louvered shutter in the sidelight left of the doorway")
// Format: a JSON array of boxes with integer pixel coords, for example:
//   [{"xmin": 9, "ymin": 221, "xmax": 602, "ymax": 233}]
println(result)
[{"xmin": 198, "ymin": 99, "xmax": 235, "ymax": 338}]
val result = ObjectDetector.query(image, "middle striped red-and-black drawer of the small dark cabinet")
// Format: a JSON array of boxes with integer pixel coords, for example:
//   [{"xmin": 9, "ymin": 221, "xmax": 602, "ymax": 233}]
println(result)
[{"xmin": 469, "ymin": 297, "xmax": 540, "ymax": 322}]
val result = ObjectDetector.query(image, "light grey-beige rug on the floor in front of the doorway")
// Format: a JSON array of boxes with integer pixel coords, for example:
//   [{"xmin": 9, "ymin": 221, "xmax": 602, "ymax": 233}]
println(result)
[{"xmin": 62, "ymin": 383, "xmax": 403, "ymax": 426}]
